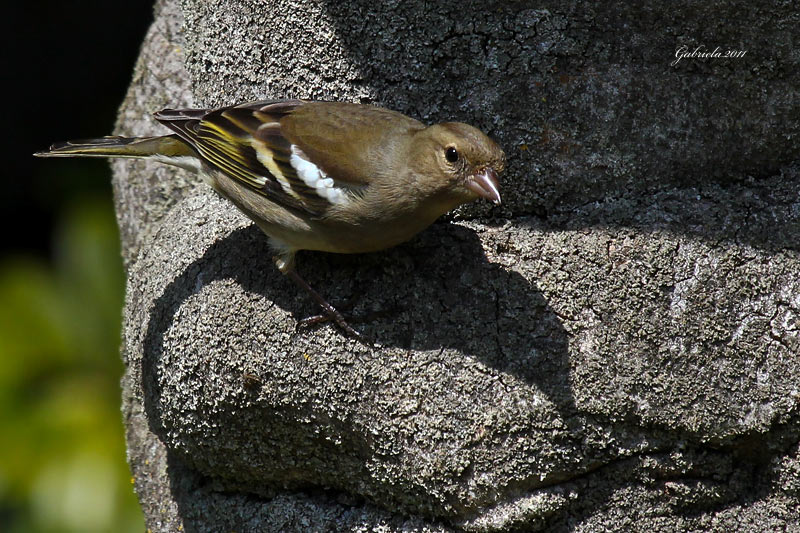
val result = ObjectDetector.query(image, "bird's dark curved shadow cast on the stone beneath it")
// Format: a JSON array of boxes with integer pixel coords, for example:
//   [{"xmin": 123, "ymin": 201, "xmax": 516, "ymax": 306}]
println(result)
[{"xmin": 142, "ymin": 224, "xmax": 574, "ymax": 434}]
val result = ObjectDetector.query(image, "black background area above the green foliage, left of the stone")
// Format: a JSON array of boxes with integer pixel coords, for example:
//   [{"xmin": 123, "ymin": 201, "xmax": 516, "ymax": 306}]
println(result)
[{"xmin": 5, "ymin": 0, "xmax": 152, "ymax": 256}]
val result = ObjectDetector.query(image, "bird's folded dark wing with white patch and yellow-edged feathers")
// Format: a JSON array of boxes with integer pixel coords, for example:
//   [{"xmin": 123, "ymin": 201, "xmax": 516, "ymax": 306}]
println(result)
[{"xmin": 155, "ymin": 100, "xmax": 351, "ymax": 217}]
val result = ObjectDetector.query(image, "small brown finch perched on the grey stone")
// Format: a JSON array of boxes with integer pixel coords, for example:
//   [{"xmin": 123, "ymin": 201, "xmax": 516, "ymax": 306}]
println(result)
[{"xmin": 34, "ymin": 100, "xmax": 505, "ymax": 338}]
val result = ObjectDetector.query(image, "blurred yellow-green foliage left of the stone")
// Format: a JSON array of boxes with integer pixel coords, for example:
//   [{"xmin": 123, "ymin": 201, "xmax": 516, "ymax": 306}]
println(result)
[{"xmin": 0, "ymin": 197, "xmax": 144, "ymax": 533}]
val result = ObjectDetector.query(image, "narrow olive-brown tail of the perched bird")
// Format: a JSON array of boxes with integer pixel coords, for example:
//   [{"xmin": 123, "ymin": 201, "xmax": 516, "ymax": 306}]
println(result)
[{"xmin": 33, "ymin": 135, "xmax": 199, "ymax": 167}]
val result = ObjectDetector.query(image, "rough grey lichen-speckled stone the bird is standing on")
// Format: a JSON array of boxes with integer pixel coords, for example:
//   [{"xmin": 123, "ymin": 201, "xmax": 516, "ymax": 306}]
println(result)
[{"xmin": 120, "ymin": 0, "xmax": 800, "ymax": 532}]
